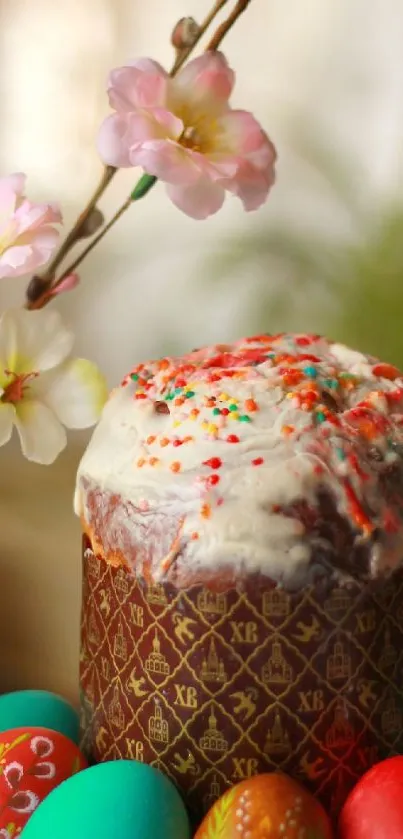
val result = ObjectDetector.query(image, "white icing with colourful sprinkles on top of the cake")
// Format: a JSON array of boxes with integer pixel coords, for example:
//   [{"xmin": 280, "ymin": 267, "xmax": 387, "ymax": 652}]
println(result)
[{"xmin": 75, "ymin": 335, "xmax": 403, "ymax": 584}]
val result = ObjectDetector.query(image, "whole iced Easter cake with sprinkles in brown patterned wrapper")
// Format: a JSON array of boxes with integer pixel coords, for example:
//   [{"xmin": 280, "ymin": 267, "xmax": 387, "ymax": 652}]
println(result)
[{"xmin": 75, "ymin": 334, "xmax": 403, "ymax": 814}]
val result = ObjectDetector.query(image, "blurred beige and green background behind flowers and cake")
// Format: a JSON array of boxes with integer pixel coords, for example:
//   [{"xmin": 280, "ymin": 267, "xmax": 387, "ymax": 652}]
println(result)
[{"xmin": 0, "ymin": 0, "xmax": 403, "ymax": 700}]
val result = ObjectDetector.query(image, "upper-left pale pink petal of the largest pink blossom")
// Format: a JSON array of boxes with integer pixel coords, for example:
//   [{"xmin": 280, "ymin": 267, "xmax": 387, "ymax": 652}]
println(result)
[{"xmin": 108, "ymin": 59, "xmax": 168, "ymax": 112}]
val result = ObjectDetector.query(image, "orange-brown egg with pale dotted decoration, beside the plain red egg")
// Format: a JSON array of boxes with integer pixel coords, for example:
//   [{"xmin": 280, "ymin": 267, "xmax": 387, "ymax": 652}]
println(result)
[{"xmin": 195, "ymin": 772, "xmax": 333, "ymax": 839}]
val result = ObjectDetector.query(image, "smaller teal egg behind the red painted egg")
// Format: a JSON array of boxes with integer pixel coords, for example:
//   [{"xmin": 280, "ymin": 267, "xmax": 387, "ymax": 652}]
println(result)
[{"xmin": 0, "ymin": 690, "xmax": 80, "ymax": 743}]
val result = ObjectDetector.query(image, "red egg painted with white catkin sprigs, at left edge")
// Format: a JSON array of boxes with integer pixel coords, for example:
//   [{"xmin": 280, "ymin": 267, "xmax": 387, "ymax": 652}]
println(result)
[{"xmin": 0, "ymin": 727, "xmax": 87, "ymax": 837}]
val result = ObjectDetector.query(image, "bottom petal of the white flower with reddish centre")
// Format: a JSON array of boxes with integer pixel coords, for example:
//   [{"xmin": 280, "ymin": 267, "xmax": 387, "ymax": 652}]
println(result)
[{"xmin": 15, "ymin": 399, "xmax": 67, "ymax": 466}]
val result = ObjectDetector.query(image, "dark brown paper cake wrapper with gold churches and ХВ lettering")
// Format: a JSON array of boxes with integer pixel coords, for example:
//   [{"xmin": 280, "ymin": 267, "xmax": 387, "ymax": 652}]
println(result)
[{"xmin": 80, "ymin": 537, "xmax": 403, "ymax": 819}]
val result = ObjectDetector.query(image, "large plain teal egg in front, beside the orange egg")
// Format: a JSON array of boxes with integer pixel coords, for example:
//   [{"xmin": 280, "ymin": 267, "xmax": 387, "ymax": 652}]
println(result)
[{"xmin": 22, "ymin": 760, "xmax": 190, "ymax": 839}]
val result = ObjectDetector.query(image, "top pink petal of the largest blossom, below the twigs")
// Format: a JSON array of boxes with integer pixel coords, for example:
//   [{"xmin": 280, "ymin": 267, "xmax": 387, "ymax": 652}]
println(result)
[{"xmin": 172, "ymin": 52, "xmax": 235, "ymax": 107}]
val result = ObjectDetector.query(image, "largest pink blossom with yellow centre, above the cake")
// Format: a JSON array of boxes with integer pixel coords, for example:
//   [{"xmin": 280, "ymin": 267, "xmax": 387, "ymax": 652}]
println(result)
[{"xmin": 98, "ymin": 52, "xmax": 276, "ymax": 219}]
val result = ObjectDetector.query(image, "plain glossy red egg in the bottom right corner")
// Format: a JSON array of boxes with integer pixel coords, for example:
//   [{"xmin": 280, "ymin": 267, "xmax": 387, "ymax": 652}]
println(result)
[{"xmin": 339, "ymin": 756, "xmax": 403, "ymax": 839}]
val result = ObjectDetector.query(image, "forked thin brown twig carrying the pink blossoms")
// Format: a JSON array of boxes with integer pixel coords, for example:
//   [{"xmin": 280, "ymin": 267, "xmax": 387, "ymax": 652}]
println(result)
[{"xmin": 26, "ymin": 0, "xmax": 251, "ymax": 310}]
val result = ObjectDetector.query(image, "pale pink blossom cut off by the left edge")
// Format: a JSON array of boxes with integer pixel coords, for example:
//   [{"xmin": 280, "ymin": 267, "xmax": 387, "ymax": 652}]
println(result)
[{"xmin": 0, "ymin": 173, "xmax": 62, "ymax": 279}]
